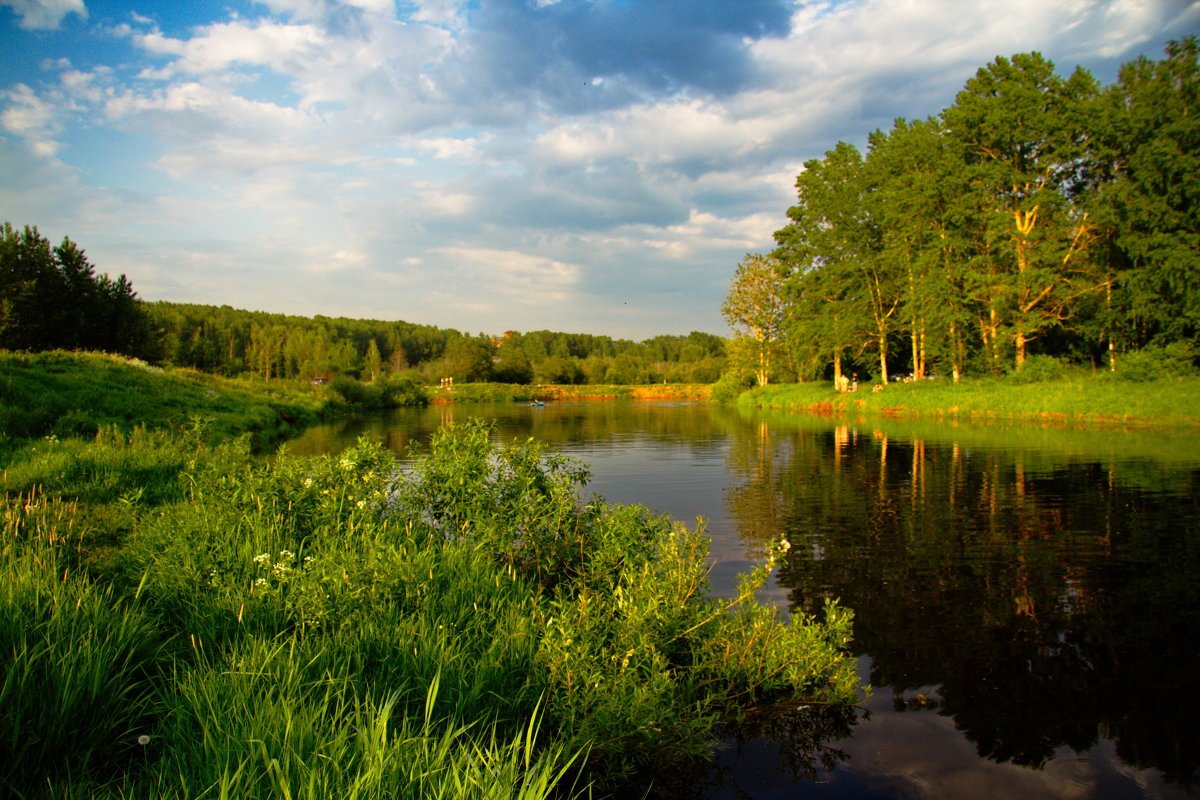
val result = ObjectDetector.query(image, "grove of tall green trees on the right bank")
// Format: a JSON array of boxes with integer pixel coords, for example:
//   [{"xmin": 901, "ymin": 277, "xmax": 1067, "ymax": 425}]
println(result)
[{"xmin": 724, "ymin": 37, "xmax": 1200, "ymax": 383}]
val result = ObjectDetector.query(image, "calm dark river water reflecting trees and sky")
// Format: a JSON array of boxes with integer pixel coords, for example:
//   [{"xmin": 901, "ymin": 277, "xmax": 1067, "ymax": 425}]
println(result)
[{"xmin": 290, "ymin": 403, "xmax": 1200, "ymax": 800}]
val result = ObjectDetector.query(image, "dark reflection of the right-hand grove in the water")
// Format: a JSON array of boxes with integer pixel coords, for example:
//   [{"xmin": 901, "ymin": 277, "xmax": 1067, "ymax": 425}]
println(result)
[{"xmin": 727, "ymin": 423, "xmax": 1200, "ymax": 787}]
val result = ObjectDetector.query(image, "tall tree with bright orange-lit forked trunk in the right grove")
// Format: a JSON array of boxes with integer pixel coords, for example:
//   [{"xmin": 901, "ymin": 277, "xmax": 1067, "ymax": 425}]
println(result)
[{"xmin": 942, "ymin": 53, "xmax": 1099, "ymax": 368}]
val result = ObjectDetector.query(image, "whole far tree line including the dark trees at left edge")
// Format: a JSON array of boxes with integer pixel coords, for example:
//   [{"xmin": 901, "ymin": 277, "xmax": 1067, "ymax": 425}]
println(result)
[{"xmin": 0, "ymin": 223, "xmax": 725, "ymax": 384}]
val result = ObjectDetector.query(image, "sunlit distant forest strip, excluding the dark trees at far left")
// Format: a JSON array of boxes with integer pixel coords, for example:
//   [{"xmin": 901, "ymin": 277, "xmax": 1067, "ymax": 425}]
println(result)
[{"xmin": 146, "ymin": 302, "xmax": 725, "ymax": 384}]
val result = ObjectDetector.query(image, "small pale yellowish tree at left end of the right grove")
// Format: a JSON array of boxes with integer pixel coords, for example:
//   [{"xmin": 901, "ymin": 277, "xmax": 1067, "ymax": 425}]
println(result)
[{"xmin": 721, "ymin": 253, "xmax": 784, "ymax": 386}]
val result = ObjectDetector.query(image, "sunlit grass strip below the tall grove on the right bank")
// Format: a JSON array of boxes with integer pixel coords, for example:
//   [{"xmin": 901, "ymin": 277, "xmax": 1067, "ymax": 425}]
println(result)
[{"xmin": 738, "ymin": 374, "xmax": 1200, "ymax": 427}]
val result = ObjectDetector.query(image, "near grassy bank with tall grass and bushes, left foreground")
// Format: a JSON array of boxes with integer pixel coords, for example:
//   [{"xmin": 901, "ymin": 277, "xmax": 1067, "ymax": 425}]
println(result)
[{"xmin": 0, "ymin": 359, "xmax": 858, "ymax": 799}]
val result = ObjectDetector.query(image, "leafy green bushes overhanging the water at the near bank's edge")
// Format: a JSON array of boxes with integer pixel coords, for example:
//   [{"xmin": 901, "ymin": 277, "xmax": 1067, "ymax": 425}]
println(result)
[{"xmin": 395, "ymin": 421, "xmax": 856, "ymax": 775}]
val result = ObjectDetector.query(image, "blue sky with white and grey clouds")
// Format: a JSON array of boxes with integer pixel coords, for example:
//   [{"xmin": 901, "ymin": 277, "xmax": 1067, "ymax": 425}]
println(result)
[{"xmin": 0, "ymin": 0, "xmax": 1200, "ymax": 339}]
